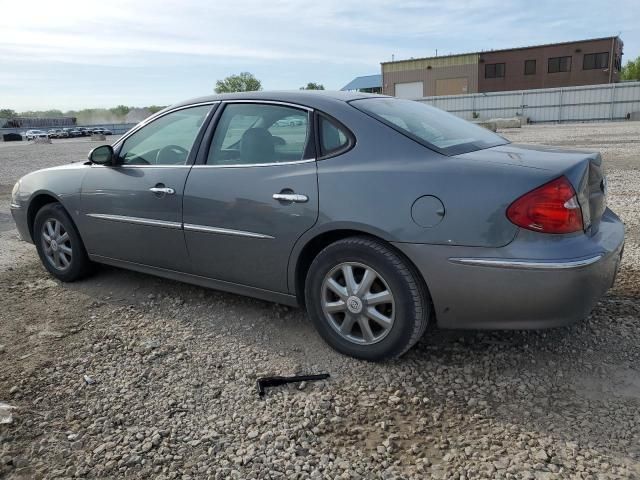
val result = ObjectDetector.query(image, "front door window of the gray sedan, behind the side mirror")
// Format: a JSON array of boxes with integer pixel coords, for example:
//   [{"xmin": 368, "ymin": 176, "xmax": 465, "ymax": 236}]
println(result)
[{"xmin": 119, "ymin": 105, "xmax": 211, "ymax": 165}]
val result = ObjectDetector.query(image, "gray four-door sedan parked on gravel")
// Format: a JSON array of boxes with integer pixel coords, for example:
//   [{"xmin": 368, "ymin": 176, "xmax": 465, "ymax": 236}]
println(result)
[{"xmin": 11, "ymin": 92, "xmax": 624, "ymax": 360}]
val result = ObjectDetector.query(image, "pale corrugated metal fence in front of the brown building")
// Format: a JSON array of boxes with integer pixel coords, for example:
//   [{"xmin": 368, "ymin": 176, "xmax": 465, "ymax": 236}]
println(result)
[{"xmin": 417, "ymin": 82, "xmax": 640, "ymax": 122}]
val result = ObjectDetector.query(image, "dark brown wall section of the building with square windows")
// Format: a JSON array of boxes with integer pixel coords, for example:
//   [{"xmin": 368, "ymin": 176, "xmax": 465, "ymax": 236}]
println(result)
[{"xmin": 478, "ymin": 37, "xmax": 622, "ymax": 92}]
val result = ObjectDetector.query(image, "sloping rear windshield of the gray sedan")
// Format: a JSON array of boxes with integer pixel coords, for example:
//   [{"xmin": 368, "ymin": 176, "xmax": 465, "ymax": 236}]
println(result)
[{"xmin": 350, "ymin": 98, "xmax": 509, "ymax": 155}]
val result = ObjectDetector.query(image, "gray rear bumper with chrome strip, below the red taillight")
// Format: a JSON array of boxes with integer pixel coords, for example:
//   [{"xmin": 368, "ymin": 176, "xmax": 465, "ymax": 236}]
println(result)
[{"xmin": 395, "ymin": 210, "xmax": 624, "ymax": 329}]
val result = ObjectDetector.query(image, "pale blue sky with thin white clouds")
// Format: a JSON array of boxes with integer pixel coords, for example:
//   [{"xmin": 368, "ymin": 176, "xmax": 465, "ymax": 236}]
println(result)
[{"xmin": 0, "ymin": 0, "xmax": 640, "ymax": 111}]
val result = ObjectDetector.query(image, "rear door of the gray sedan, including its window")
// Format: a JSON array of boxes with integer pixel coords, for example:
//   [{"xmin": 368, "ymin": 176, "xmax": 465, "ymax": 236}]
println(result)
[{"xmin": 183, "ymin": 102, "xmax": 318, "ymax": 293}]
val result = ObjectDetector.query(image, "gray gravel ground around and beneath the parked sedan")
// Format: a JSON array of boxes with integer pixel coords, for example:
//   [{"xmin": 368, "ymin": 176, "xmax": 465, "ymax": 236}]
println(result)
[{"xmin": 0, "ymin": 123, "xmax": 640, "ymax": 479}]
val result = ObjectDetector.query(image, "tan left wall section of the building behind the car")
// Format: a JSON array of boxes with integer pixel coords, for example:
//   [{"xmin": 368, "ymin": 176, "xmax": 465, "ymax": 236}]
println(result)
[{"xmin": 382, "ymin": 54, "xmax": 478, "ymax": 96}]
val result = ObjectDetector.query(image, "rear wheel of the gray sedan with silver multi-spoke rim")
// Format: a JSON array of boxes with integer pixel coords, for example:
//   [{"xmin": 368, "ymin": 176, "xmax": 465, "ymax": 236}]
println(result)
[{"xmin": 305, "ymin": 236, "xmax": 432, "ymax": 361}]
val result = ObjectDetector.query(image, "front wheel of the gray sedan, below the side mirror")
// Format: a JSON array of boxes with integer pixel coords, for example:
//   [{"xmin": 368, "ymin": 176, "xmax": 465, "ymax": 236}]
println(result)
[{"xmin": 33, "ymin": 203, "xmax": 92, "ymax": 282}]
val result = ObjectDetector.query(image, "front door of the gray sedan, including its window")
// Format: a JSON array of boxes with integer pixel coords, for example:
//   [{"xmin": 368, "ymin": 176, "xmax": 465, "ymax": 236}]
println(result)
[{"xmin": 80, "ymin": 104, "xmax": 212, "ymax": 271}]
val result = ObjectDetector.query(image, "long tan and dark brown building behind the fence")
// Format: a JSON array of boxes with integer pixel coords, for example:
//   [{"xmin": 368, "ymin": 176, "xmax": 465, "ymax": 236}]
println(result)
[{"xmin": 382, "ymin": 36, "xmax": 623, "ymax": 98}]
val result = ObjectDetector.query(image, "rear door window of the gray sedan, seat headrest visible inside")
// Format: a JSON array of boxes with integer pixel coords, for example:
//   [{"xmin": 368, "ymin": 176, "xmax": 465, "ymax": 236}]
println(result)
[{"xmin": 207, "ymin": 103, "xmax": 309, "ymax": 165}]
